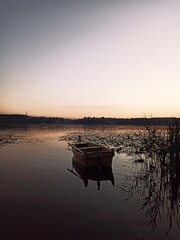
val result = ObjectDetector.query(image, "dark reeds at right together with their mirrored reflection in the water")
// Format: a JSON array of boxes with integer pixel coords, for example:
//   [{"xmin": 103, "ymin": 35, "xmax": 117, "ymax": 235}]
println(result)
[{"xmin": 119, "ymin": 120, "xmax": 180, "ymax": 233}]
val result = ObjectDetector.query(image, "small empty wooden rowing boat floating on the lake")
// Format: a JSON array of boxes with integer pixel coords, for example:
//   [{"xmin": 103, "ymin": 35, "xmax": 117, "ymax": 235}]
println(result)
[{"xmin": 70, "ymin": 142, "xmax": 114, "ymax": 167}]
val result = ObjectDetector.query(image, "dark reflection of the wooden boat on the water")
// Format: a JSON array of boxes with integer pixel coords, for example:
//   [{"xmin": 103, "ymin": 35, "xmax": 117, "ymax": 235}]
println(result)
[{"xmin": 68, "ymin": 156, "xmax": 114, "ymax": 190}]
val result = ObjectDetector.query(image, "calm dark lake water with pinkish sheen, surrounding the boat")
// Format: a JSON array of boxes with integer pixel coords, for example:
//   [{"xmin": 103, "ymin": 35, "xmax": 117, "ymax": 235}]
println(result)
[{"xmin": 0, "ymin": 125, "xmax": 180, "ymax": 240}]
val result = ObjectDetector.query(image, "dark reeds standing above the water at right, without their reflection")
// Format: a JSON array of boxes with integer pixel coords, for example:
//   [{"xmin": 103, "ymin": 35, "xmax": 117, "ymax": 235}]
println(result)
[{"xmin": 133, "ymin": 119, "xmax": 180, "ymax": 164}]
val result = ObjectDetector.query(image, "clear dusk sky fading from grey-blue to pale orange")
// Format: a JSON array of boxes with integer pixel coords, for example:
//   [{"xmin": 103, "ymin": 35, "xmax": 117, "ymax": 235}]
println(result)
[{"xmin": 0, "ymin": 0, "xmax": 180, "ymax": 118}]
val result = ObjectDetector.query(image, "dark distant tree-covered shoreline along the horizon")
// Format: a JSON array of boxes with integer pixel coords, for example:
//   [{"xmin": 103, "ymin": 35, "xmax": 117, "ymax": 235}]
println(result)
[{"xmin": 0, "ymin": 114, "xmax": 176, "ymax": 126}]
